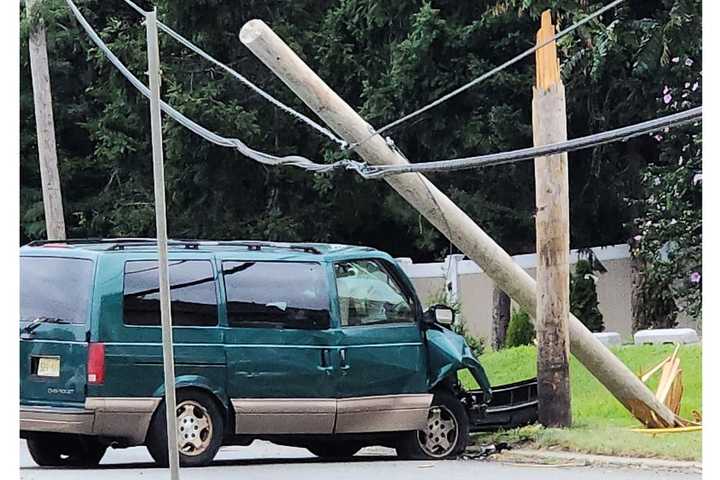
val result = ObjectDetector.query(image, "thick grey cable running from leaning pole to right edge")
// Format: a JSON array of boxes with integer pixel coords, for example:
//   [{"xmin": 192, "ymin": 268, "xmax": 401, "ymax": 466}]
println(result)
[{"xmin": 350, "ymin": 106, "xmax": 702, "ymax": 178}]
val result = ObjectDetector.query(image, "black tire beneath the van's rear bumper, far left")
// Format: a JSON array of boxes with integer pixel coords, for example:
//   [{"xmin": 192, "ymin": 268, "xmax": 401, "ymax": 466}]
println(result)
[{"xmin": 27, "ymin": 434, "xmax": 107, "ymax": 467}]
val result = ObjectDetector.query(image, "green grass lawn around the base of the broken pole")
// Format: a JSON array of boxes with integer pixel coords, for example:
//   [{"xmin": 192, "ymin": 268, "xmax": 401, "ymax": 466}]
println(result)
[{"xmin": 461, "ymin": 345, "xmax": 702, "ymax": 460}]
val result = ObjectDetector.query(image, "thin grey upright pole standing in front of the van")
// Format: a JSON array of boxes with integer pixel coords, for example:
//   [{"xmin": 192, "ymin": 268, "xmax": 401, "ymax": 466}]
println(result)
[{"xmin": 145, "ymin": 10, "xmax": 180, "ymax": 480}]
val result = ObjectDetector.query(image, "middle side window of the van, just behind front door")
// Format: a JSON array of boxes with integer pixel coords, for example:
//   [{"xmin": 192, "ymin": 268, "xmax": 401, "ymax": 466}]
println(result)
[{"xmin": 222, "ymin": 261, "xmax": 330, "ymax": 329}]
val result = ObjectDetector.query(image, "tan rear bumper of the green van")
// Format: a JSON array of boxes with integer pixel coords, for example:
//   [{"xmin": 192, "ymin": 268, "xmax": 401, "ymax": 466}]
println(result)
[{"xmin": 20, "ymin": 398, "xmax": 160, "ymax": 445}]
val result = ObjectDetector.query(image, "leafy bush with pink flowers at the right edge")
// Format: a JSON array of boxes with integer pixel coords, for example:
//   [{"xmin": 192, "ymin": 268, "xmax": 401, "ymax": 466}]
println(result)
[{"xmin": 630, "ymin": 52, "xmax": 702, "ymax": 329}]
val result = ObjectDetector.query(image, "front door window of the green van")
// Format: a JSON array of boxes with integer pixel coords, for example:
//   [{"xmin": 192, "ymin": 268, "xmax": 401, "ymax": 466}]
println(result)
[{"xmin": 335, "ymin": 260, "xmax": 415, "ymax": 327}]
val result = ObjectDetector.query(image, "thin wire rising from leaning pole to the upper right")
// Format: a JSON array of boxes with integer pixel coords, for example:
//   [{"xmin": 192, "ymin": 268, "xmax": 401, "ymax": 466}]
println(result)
[{"xmin": 349, "ymin": 0, "xmax": 625, "ymax": 150}]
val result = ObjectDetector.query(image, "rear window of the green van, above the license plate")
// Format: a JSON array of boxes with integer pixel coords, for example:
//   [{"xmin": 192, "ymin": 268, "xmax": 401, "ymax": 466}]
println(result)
[{"xmin": 20, "ymin": 257, "xmax": 93, "ymax": 324}]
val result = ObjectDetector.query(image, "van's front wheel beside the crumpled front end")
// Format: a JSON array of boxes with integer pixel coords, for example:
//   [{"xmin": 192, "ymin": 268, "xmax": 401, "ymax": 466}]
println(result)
[{"xmin": 395, "ymin": 390, "xmax": 470, "ymax": 460}]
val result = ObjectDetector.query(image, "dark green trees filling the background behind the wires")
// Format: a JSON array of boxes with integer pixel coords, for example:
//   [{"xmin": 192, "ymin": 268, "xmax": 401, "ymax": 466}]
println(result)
[{"xmin": 20, "ymin": 0, "xmax": 701, "ymax": 261}]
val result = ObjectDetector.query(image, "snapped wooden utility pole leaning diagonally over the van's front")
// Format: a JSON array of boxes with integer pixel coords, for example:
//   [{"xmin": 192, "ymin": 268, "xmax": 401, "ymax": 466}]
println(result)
[{"xmin": 240, "ymin": 20, "xmax": 675, "ymax": 426}]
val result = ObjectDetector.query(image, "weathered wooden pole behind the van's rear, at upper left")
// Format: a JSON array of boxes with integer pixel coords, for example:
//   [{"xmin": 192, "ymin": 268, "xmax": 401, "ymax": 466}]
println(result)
[{"xmin": 25, "ymin": 0, "xmax": 65, "ymax": 240}]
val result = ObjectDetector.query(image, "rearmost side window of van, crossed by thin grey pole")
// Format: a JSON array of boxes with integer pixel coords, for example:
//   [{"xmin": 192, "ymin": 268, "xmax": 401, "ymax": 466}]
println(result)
[{"xmin": 123, "ymin": 260, "xmax": 218, "ymax": 327}]
